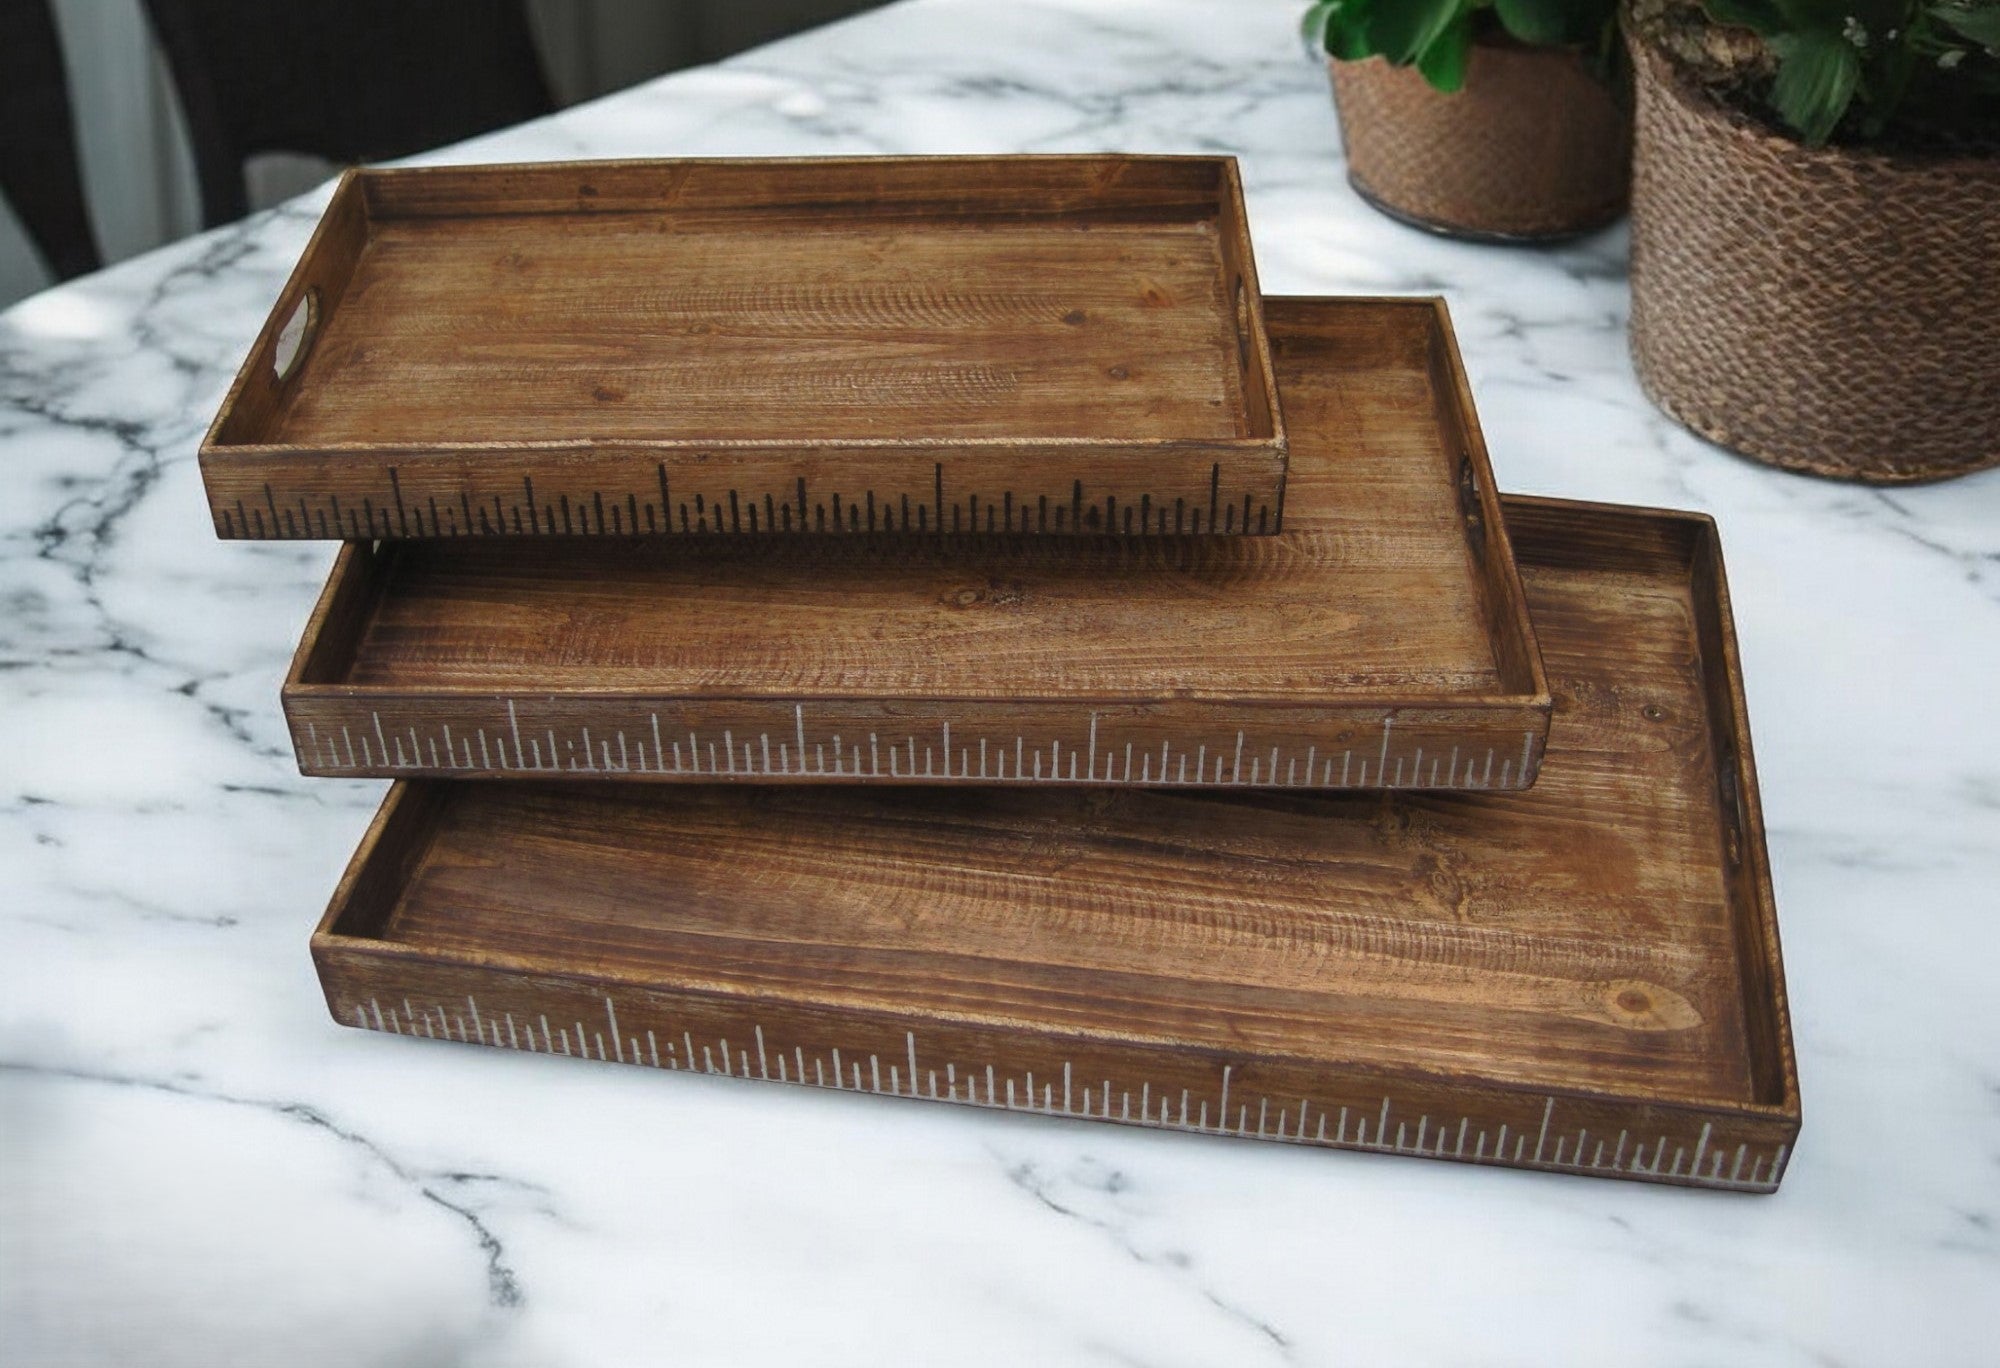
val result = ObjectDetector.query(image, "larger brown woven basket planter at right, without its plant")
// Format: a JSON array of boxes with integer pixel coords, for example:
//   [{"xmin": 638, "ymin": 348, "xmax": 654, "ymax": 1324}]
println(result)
[{"xmin": 1632, "ymin": 42, "xmax": 2000, "ymax": 484}]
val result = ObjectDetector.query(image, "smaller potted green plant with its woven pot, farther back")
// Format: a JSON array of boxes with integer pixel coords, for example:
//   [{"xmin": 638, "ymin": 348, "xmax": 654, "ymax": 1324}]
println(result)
[{"xmin": 1304, "ymin": 0, "xmax": 1632, "ymax": 242}]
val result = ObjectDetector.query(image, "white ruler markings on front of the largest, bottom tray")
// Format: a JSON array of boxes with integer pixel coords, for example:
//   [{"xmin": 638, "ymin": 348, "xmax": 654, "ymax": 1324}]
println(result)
[{"xmin": 352, "ymin": 994, "xmax": 1790, "ymax": 1192}]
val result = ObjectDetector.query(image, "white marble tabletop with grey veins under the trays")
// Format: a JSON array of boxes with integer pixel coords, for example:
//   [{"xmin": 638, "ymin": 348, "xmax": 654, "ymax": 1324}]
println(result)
[{"xmin": 0, "ymin": 0, "xmax": 2000, "ymax": 1368}]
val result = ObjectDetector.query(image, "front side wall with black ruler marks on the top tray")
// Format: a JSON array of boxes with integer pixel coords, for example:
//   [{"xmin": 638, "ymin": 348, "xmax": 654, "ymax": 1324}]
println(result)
[{"xmin": 202, "ymin": 440, "xmax": 1284, "ymax": 540}]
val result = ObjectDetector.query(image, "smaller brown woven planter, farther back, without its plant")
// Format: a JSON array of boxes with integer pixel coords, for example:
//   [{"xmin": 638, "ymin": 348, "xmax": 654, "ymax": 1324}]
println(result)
[{"xmin": 1326, "ymin": 40, "xmax": 1632, "ymax": 242}]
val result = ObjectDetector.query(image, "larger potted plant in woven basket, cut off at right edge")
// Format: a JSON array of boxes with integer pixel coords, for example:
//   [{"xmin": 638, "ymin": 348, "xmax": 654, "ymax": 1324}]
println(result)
[{"xmin": 1630, "ymin": 0, "xmax": 2000, "ymax": 484}]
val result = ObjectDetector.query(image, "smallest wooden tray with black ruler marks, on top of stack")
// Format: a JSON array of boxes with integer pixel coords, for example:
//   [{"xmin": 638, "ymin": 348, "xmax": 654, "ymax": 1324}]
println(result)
[{"xmin": 202, "ymin": 156, "xmax": 1286, "ymax": 538}]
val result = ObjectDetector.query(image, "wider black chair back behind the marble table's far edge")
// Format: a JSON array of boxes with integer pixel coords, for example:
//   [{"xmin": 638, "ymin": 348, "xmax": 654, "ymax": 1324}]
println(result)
[{"xmin": 146, "ymin": 0, "xmax": 554, "ymax": 228}]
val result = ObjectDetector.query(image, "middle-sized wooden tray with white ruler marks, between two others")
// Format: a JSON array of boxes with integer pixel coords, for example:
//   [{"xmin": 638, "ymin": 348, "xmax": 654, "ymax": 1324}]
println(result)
[{"xmin": 284, "ymin": 300, "xmax": 1548, "ymax": 788}]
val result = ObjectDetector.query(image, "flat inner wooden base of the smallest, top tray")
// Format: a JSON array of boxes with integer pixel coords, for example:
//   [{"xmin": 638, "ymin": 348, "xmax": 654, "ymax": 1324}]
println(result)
[{"xmin": 270, "ymin": 214, "xmax": 1244, "ymax": 446}]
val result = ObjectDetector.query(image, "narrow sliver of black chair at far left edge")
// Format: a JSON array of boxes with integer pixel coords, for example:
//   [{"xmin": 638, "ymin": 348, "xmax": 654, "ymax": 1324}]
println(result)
[{"xmin": 0, "ymin": 0, "xmax": 104, "ymax": 280}]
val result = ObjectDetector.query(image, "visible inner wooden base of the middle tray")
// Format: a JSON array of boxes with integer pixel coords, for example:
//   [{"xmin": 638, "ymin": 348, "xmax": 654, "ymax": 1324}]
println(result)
[{"xmin": 314, "ymin": 302, "xmax": 1524, "ymax": 704}]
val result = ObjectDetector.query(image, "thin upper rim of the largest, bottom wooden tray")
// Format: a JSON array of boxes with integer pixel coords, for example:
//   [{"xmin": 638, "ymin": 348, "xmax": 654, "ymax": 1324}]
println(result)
[{"xmin": 310, "ymin": 494, "xmax": 1804, "ymax": 1130}]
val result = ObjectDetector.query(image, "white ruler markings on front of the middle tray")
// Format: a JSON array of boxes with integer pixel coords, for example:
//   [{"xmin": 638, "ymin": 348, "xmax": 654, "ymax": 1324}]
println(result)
[{"xmin": 292, "ymin": 698, "xmax": 1536, "ymax": 790}]
